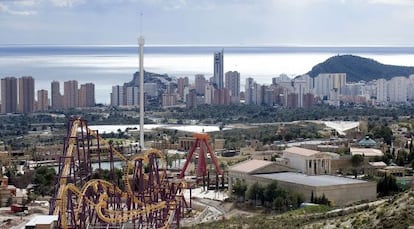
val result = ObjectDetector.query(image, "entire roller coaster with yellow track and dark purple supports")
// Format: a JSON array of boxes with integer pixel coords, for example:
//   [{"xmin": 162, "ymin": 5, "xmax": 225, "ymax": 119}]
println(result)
[{"xmin": 49, "ymin": 118, "xmax": 186, "ymax": 229}]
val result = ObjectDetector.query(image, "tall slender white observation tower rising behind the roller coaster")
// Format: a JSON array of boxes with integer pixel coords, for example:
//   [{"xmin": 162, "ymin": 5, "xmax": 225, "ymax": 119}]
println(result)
[{"xmin": 138, "ymin": 35, "xmax": 145, "ymax": 150}]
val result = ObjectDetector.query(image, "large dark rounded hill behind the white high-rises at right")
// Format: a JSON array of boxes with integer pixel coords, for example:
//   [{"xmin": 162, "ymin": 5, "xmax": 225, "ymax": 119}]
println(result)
[{"xmin": 307, "ymin": 55, "xmax": 414, "ymax": 82}]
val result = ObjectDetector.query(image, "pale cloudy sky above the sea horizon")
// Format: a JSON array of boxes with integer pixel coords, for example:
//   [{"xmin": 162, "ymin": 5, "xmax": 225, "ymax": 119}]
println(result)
[{"xmin": 0, "ymin": 0, "xmax": 414, "ymax": 46}]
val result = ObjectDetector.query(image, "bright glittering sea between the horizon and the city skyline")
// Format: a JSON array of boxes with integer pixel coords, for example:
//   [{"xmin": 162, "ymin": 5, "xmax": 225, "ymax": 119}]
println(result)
[{"xmin": 0, "ymin": 45, "xmax": 414, "ymax": 104}]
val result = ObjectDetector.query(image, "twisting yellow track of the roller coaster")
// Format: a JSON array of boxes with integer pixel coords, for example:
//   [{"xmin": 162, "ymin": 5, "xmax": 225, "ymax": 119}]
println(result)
[{"xmin": 53, "ymin": 119, "xmax": 185, "ymax": 228}]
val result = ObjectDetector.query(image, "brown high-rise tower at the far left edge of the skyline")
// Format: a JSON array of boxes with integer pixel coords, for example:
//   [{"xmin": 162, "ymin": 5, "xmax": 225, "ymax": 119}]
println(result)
[{"xmin": 1, "ymin": 77, "xmax": 17, "ymax": 114}]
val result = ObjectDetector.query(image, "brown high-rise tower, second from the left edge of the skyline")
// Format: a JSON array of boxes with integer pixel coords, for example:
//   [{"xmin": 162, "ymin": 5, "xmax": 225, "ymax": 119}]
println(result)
[{"xmin": 18, "ymin": 76, "xmax": 35, "ymax": 114}]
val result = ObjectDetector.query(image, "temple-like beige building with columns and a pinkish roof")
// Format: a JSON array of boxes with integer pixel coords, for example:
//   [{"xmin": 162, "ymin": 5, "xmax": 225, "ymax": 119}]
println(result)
[{"xmin": 283, "ymin": 147, "xmax": 332, "ymax": 175}]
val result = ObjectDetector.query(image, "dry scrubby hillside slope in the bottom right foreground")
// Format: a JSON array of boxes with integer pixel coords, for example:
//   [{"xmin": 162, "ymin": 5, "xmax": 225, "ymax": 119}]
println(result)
[{"xmin": 193, "ymin": 191, "xmax": 414, "ymax": 229}]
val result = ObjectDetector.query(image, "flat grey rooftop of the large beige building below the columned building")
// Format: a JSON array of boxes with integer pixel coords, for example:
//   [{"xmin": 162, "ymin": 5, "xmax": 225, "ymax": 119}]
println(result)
[{"xmin": 254, "ymin": 172, "xmax": 367, "ymax": 187}]
